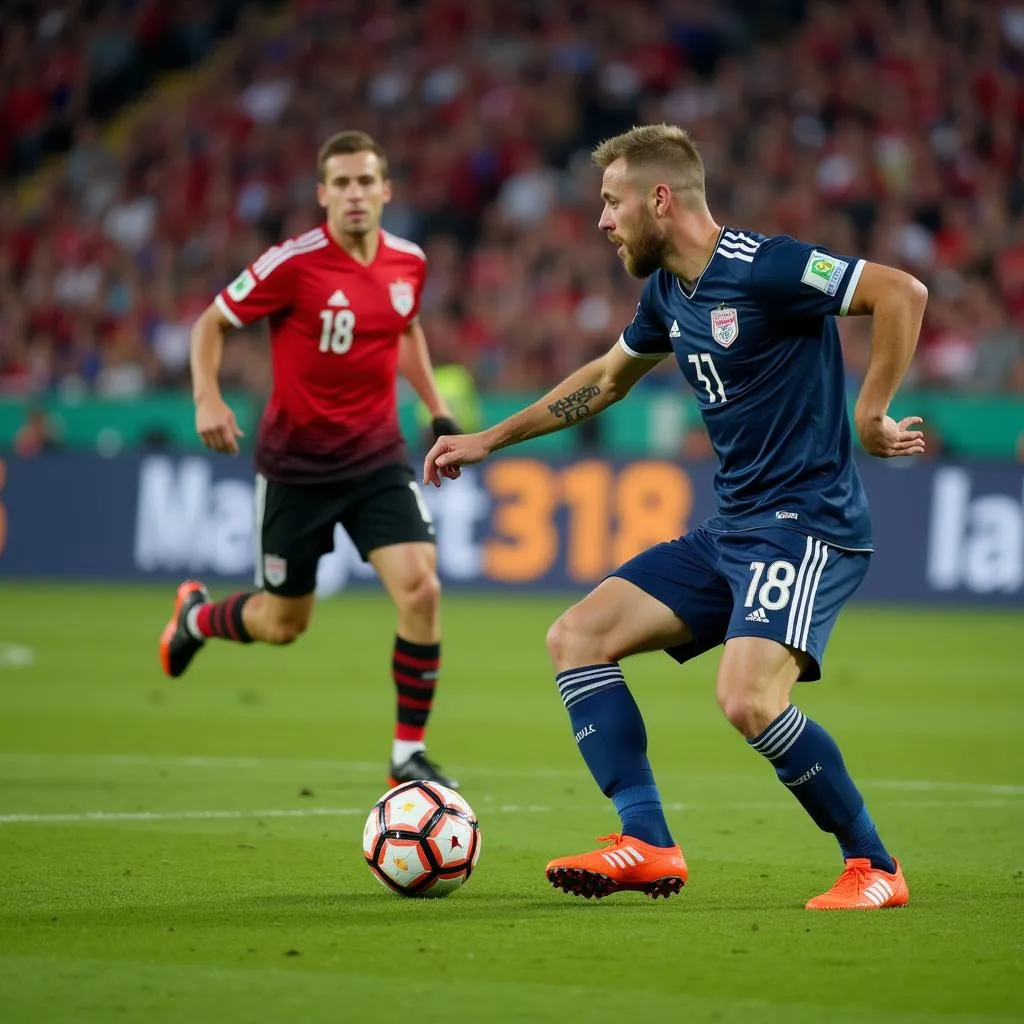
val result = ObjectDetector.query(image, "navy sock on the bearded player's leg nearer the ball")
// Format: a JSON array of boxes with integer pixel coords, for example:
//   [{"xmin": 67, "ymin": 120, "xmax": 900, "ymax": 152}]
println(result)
[{"xmin": 556, "ymin": 664, "xmax": 676, "ymax": 846}]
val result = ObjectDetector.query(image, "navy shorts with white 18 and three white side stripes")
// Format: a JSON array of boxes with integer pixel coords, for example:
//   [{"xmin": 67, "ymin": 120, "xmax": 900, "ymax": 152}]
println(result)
[{"xmin": 610, "ymin": 526, "xmax": 871, "ymax": 681}]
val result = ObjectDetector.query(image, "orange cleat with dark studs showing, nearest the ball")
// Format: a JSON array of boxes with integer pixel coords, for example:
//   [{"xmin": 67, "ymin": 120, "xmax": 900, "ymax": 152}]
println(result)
[{"xmin": 545, "ymin": 833, "xmax": 687, "ymax": 899}]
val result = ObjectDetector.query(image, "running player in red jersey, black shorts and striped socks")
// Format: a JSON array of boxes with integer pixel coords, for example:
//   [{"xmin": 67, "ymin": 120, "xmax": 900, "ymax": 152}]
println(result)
[{"xmin": 160, "ymin": 131, "xmax": 458, "ymax": 787}]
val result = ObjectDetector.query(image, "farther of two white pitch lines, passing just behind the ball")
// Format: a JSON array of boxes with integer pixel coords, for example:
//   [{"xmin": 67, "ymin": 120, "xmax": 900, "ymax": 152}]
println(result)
[{"xmin": 0, "ymin": 753, "xmax": 1024, "ymax": 797}]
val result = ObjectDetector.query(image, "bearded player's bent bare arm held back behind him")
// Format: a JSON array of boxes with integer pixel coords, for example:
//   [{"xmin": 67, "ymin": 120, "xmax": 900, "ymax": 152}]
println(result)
[{"xmin": 849, "ymin": 263, "xmax": 928, "ymax": 459}]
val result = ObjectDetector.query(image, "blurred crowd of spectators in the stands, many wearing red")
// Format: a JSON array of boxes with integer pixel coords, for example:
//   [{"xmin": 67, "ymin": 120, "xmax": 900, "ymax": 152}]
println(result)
[{"xmin": 0, "ymin": 0, "xmax": 1024, "ymax": 407}]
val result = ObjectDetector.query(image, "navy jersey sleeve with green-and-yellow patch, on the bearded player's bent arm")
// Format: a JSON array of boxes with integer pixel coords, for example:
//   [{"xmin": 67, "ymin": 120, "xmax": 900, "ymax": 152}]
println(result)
[{"xmin": 751, "ymin": 234, "xmax": 864, "ymax": 316}]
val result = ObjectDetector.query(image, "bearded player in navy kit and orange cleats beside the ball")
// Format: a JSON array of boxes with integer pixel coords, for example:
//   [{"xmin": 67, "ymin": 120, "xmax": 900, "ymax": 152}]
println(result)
[{"xmin": 424, "ymin": 125, "xmax": 928, "ymax": 909}]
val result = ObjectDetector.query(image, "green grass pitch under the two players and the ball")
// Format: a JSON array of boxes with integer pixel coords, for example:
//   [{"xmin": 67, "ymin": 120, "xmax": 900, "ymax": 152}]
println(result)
[{"xmin": 0, "ymin": 583, "xmax": 1024, "ymax": 1024}]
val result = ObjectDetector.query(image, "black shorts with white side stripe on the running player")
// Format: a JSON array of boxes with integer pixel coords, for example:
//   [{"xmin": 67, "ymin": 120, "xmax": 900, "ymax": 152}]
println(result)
[{"xmin": 255, "ymin": 465, "xmax": 434, "ymax": 597}]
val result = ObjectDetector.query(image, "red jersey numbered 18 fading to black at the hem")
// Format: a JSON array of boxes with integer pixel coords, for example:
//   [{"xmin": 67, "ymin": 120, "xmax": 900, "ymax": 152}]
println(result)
[{"xmin": 215, "ymin": 224, "xmax": 427, "ymax": 483}]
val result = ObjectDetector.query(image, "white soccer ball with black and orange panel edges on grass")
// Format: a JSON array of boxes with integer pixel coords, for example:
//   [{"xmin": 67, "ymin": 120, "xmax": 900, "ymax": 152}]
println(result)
[{"xmin": 362, "ymin": 781, "xmax": 480, "ymax": 896}]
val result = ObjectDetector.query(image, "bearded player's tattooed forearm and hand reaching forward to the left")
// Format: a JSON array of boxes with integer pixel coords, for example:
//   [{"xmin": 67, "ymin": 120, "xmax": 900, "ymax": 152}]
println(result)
[{"xmin": 423, "ymin": 343, "xmax": 657, "ymax": 487}]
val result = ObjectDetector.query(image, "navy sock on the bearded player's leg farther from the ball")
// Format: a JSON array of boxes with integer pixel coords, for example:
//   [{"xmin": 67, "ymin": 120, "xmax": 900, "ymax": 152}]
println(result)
[{"xmin": 748, "ymin": 705, "xmax": 896, "ymax": 871}]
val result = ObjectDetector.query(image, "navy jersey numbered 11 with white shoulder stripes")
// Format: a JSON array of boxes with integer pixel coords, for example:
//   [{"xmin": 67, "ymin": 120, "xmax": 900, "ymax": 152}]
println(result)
[{"xmin": 620, "ymin": 227, "xmax": 871, "ymax": 550}]
